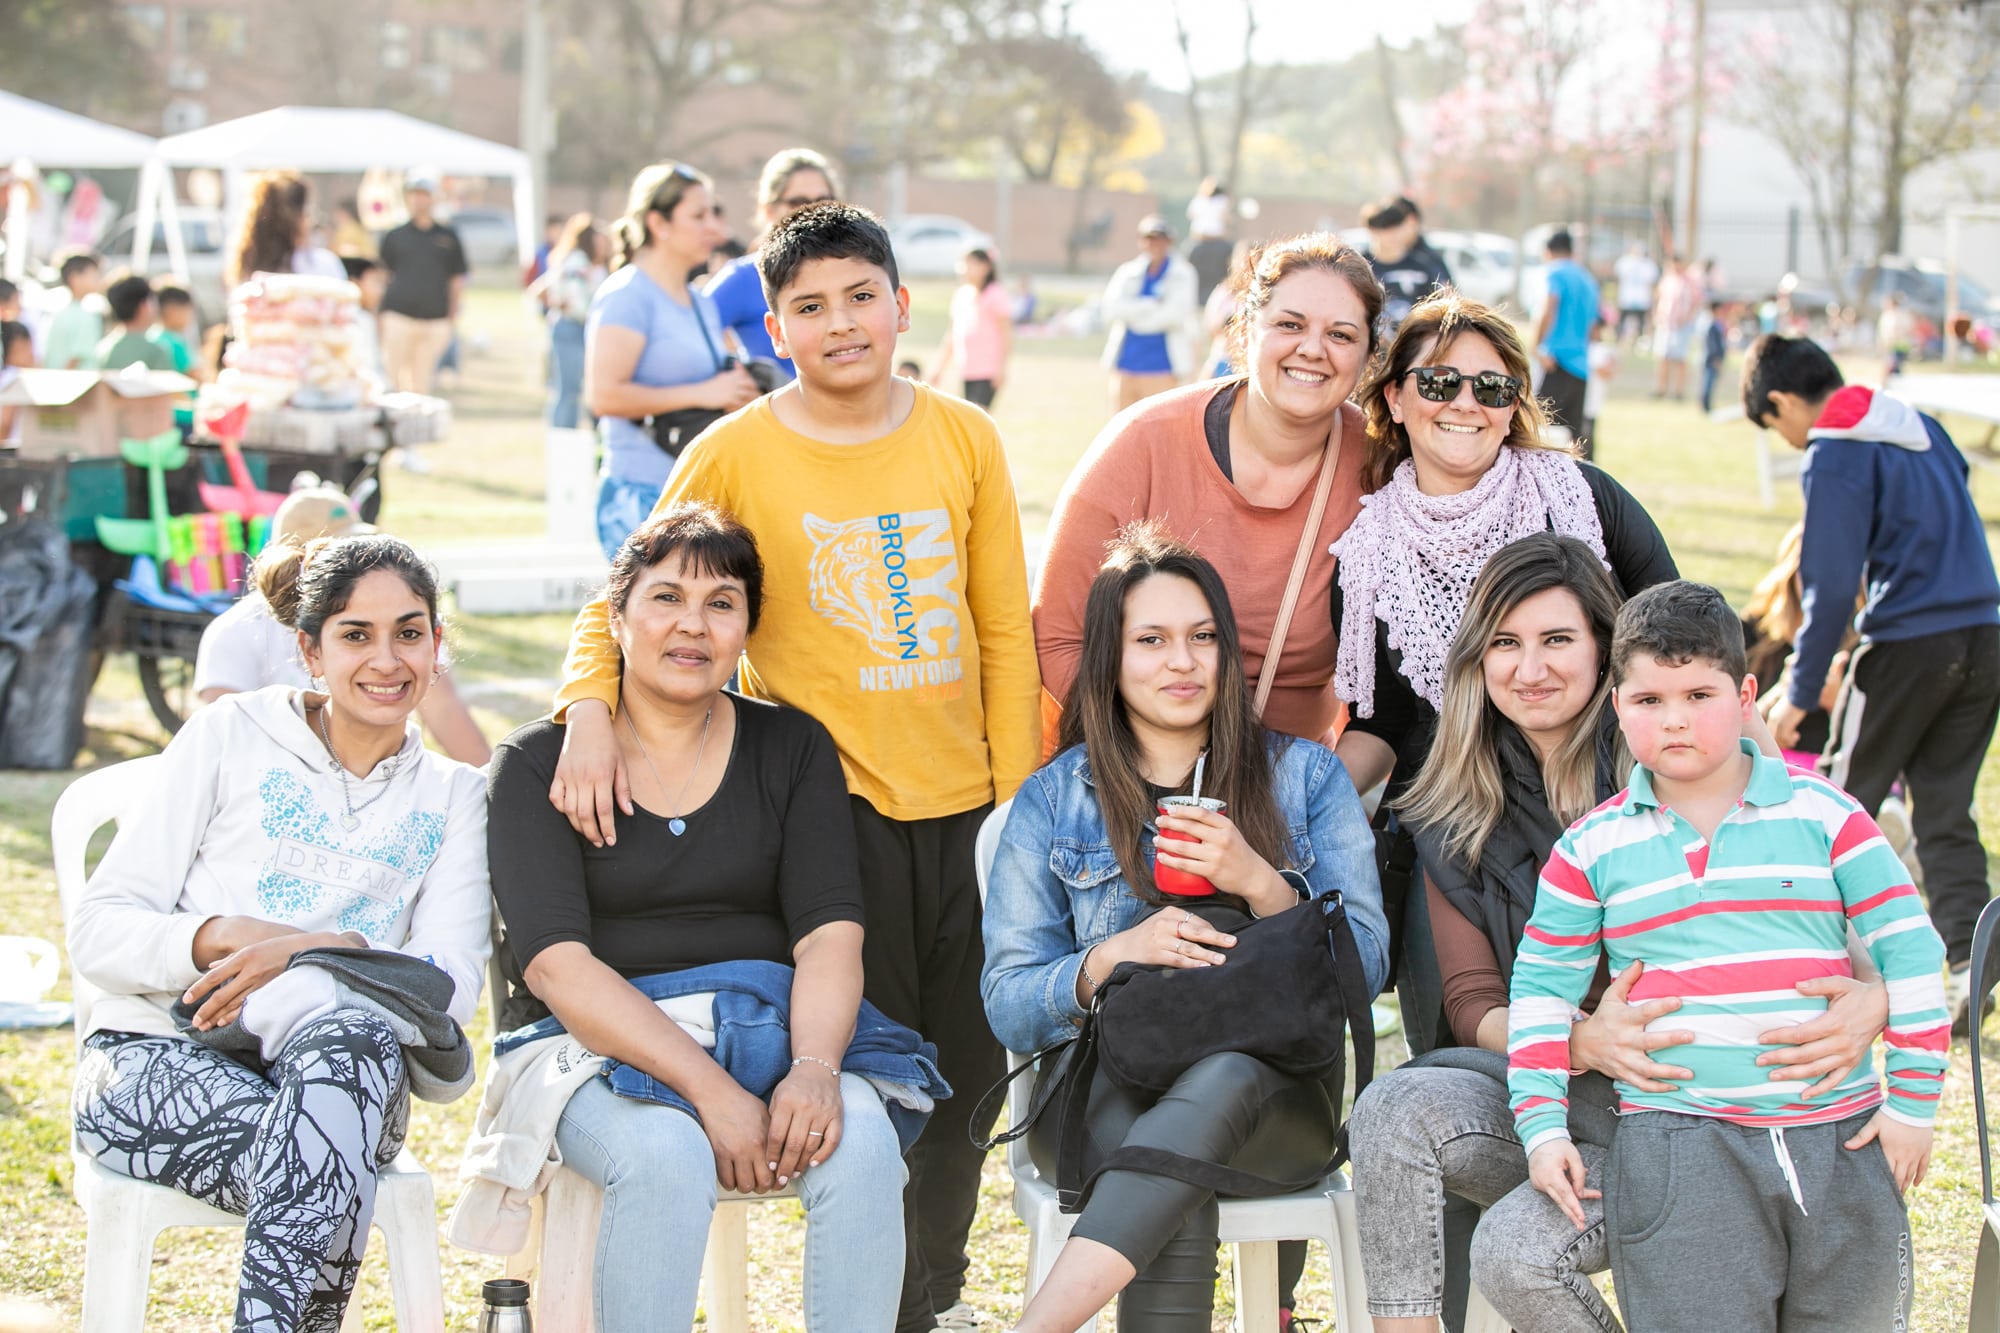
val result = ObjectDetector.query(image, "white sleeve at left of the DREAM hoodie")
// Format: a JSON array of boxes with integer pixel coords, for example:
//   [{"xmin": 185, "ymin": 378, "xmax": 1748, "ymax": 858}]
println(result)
[{"xmin": 68, "ymin": 701, "xmax": 230, "ymax": 995}]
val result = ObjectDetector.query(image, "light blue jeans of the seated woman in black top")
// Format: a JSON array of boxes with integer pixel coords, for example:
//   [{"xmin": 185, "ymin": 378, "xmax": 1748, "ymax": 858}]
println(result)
[{"xmin": 556, "ymin": 1075, "xmax": 904, "ymax": 1333}]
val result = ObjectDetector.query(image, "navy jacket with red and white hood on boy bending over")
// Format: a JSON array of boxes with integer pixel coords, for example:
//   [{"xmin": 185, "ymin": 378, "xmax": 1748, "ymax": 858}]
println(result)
[{"xmin": 1790, "ymin": 384, "xmax": 2000, "ymax": 711}]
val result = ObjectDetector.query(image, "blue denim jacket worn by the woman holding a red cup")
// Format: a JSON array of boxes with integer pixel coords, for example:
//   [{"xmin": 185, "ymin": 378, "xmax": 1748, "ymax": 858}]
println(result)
[{"xmin": 980, "ymin": 735, "xmax": 1388, "ymax": 1053}]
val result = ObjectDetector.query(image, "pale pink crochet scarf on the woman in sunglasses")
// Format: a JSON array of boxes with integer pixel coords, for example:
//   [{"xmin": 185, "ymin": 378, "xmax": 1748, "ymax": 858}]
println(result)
[{"xmin": 1334, "ymin": 446, "xmax": 1610, "ymax": 717}]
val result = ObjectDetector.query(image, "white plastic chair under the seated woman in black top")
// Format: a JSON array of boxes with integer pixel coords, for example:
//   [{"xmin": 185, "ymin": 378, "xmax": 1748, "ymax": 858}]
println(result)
[{"xmin": 506, "ymin": 1167, "xmax": 798, "ymax": 1333}]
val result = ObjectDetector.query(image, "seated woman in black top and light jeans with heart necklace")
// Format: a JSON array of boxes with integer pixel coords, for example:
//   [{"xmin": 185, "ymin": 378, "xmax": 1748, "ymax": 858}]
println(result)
[{"xmin": 490, "ymin": 502, "xmax": 916, "ymax": 1333}]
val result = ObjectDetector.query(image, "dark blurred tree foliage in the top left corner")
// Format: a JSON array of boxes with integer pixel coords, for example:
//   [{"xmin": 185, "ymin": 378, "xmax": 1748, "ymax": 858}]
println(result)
[{"xmin": 0, "ymin": 0, "xmax": 160, "ymax": 118}]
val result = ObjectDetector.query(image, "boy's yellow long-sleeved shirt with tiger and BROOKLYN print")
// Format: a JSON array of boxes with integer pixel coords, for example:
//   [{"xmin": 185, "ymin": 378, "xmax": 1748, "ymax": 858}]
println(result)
[{"xmin": 556, "ymin": 386, "xmax": 1040, "ymax": 819}]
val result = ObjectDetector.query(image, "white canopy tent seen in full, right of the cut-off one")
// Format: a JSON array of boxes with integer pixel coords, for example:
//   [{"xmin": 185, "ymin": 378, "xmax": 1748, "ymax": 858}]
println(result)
[{"xmin": 136, "ymin": 106, "xmax": 536, "ymax": 272}]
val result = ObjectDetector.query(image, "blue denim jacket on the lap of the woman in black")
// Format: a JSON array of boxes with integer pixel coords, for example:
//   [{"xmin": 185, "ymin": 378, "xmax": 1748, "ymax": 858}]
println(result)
[{"xmin": 494, "ymin": 959, "xmax": 952, "ymax": 1153}]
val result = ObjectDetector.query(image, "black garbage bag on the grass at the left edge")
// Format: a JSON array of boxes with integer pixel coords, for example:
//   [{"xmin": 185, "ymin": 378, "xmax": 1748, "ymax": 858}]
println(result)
[{"xmin": 0, "ymin": 518, "xmax": 98, "ymax": 769}]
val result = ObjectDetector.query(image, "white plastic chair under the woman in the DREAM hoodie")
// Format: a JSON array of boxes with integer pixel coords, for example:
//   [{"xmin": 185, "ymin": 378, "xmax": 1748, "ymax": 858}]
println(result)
[{"xmin": 50, "ymin": 755, "xmax": 444, "ymax": 1333}]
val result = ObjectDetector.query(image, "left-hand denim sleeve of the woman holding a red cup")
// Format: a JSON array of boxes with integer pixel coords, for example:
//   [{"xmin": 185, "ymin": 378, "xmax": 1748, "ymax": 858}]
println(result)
[{"xmin": 980, "ymin": 773, "xmax": 1084, "ymax": 1055}]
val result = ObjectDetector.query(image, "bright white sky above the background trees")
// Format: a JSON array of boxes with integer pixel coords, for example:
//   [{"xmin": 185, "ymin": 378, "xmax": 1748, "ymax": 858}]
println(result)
[{"xmin": 1070, "ymin": 0, "xmax": 1474, "ymax": 88}]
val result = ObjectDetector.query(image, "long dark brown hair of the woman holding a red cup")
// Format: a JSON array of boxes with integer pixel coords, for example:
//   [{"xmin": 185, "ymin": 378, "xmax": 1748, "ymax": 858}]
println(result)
[{"xmin": 1058, "ymin": 518, "xmax": 1292, "ymax": 905}]
